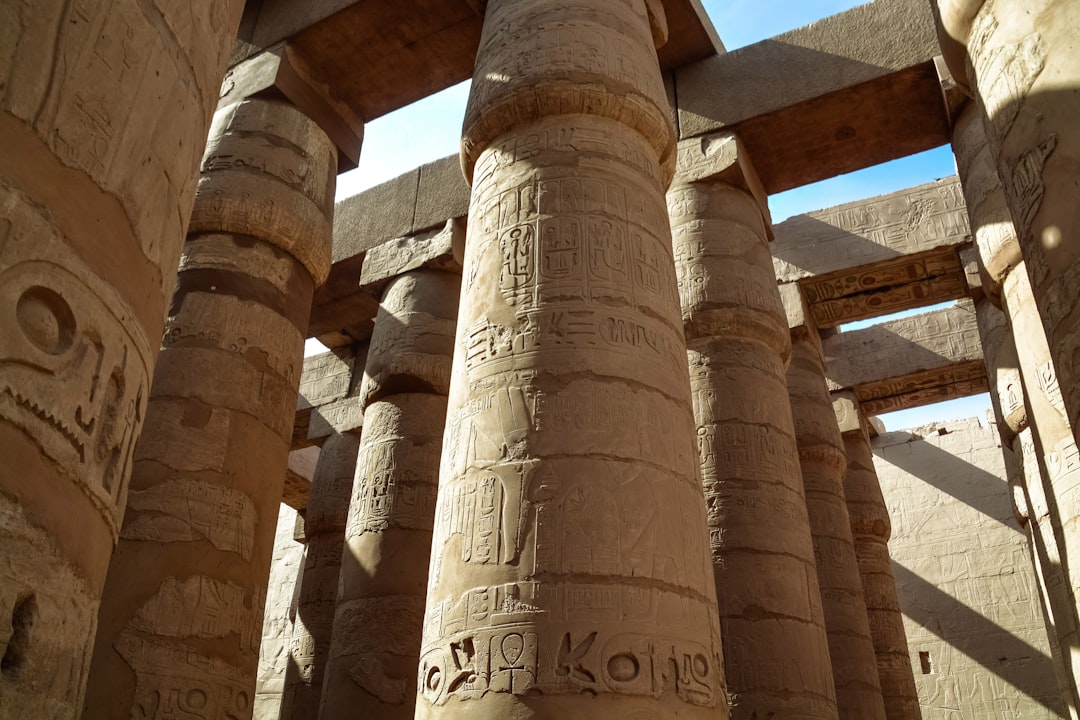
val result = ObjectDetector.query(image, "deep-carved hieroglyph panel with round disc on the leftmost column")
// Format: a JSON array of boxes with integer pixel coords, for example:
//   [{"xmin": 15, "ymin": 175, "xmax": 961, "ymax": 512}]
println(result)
[{"xmin": 0, "ymin": 185, "xmax": 151, "ymax": 533}]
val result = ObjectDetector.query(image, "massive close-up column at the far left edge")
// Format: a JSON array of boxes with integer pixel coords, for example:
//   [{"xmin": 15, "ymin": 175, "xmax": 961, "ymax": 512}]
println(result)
[{"xmin": 0, "ymin": 0, "xmax": 244, "ymax": 718}]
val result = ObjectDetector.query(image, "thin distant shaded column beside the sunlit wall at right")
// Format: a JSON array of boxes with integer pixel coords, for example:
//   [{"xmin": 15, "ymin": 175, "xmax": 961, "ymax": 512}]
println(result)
[{"xmin": 833, "ymin": 391, "xmax": 922, "ymax": 720}]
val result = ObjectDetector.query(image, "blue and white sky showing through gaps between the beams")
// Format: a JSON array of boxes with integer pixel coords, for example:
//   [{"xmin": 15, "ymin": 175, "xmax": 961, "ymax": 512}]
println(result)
[{"xmin": 321, "ymin": 0, "xmax": 989, "ymax": 430}]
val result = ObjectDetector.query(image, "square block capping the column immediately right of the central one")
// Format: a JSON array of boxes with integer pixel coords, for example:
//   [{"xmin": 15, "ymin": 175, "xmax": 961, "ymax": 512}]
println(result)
[{"xmin": 675, "ymin": 132, "xmax": 772, "ymax": 236}]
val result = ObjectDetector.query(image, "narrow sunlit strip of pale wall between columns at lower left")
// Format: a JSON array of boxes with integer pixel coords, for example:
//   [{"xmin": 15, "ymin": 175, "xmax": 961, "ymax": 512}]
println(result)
[{"xmin": 252, "ymin": 504, "xmax": 303, "ymax": 720}]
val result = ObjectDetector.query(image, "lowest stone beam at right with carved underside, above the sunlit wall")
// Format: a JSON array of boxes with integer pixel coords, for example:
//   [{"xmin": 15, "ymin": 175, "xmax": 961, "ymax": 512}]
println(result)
[{"xmin": 823, "ymin": 300, "xmax": 987, "ymax": 415}]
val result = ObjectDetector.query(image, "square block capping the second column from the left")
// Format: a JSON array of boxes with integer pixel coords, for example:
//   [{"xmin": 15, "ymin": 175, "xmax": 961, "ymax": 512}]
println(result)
[{"xmin": 218, "ymin": 43, "xmax": 364, "ymax": 172}]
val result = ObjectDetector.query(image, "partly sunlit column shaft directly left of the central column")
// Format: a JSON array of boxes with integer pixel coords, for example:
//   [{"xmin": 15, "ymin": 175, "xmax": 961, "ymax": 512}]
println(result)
[{"xmin": 319, "ymin": 269, "xmax": 461, "ymax": 720}]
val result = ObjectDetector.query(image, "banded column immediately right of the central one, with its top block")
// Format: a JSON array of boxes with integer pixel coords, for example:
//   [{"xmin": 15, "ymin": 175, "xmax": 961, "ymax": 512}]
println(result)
[{"xmin": 667, "ymin": 136, "xmax": 837, "ymax": 720}]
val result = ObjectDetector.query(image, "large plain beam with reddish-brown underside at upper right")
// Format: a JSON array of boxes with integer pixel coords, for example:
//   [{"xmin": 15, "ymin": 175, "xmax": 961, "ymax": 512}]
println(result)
[{"xmin": 675, "ymin": 0, "xmax": 949, "ymax": 193}]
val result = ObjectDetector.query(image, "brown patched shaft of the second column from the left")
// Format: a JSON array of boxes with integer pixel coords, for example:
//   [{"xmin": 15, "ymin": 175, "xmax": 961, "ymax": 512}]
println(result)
[{"xmin": 82, "ymin": 98, "xmax": 337, "ymax": 720}]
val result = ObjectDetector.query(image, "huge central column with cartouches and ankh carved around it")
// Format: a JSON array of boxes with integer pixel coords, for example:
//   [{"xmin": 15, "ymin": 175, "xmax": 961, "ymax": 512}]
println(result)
[{"xmin": 417, "ymin": 0, "xmax": 727, "ymax": 719}]
